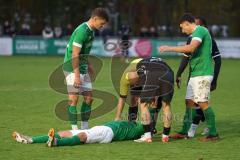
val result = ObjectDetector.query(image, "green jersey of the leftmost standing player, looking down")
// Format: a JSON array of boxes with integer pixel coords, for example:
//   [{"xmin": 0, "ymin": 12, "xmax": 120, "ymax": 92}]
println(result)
[{"xmin": 63, "ymin": 22, "xmax": 94, "ymax": 74}]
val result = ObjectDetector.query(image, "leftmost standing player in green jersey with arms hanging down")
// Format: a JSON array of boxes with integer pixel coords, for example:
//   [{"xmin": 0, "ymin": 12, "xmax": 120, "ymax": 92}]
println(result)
[{"xmin": 63, "ymin": 8, "xmax": 108, "ymax": 130}]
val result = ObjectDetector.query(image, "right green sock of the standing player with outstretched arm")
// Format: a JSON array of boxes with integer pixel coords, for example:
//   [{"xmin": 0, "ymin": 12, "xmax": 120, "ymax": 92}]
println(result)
[{"xmin": 203, "ymin": 107, "xmax": 217, "ymax": 136}]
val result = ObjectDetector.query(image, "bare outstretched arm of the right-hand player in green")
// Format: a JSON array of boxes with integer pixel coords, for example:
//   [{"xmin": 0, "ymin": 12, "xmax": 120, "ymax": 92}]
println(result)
[{"xmin": 159, "ymin": 39, "xmax": 201, "ymax": 54}]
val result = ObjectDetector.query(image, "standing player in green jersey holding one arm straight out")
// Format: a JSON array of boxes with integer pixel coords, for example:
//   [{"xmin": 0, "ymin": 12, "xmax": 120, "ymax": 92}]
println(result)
[{"xmin": 159, "ymin": 14, "xmax": 219, "ymax": 141}]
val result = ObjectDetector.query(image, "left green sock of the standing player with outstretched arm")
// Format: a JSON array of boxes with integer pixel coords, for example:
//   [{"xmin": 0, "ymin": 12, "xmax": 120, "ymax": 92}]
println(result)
[{"xmin": 179, "ymin": 107, "xmax": 196, "ymax": 134}]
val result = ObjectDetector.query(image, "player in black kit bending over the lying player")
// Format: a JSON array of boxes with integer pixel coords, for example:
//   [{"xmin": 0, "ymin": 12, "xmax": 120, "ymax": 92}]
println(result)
[{"xmin": 125, "ymin": 57, "xmax": 174, "ymax": 142}]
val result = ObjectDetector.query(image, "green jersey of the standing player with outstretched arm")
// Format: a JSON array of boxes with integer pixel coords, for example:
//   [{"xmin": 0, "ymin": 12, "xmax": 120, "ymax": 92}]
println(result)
[{"xmin": 190, "ymin": 26, "xmax": 213, "ymax": 77}]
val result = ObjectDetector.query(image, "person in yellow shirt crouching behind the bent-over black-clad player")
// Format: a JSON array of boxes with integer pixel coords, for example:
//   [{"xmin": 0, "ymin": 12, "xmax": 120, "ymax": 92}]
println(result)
[{"xmin": 115, "ymin": 58, "xmax": 162, "ymax": 134}]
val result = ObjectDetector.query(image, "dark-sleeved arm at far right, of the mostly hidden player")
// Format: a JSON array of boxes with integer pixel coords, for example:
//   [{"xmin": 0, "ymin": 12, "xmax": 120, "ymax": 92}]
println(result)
[{"xmin": 211, "ymin": 40, "xmax": 222, "ymax": 91}]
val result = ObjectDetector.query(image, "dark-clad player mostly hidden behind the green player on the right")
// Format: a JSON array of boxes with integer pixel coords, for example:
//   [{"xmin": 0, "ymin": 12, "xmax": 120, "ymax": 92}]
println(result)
[{"xmin": 176, "ymin": 17, "xmax": 221, "ymax": 138}]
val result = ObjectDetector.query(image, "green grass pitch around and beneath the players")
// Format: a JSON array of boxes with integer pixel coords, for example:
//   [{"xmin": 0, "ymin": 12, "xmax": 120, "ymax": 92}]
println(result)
[{"xmin": 0, "ymin": 56, "xmax": 240, "ymax": 160}]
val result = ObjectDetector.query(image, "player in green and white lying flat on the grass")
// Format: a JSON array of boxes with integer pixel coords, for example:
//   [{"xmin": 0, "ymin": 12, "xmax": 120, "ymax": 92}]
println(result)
[{"xmin": 13, "ymin": 121, "xmax": 144, "ymax": 147}]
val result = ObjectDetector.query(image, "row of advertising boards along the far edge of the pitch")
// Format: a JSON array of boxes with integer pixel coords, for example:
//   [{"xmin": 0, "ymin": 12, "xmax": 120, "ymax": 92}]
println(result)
[{"xmin": 10, "ymin": 37, "xmax": 240, "ymax": 58}]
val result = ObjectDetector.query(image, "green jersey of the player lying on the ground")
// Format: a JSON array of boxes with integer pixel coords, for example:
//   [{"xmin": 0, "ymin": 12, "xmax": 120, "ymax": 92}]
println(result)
[{"xmin": 104, "ymin": 121, "xmax": 144, "ymax": 141}]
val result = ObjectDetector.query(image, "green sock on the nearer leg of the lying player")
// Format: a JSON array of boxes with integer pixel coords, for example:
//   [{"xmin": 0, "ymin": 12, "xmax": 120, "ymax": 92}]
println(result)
[{"xmin": 57, "ymin": 135, "xmax": 83, "ymax": 146}]
